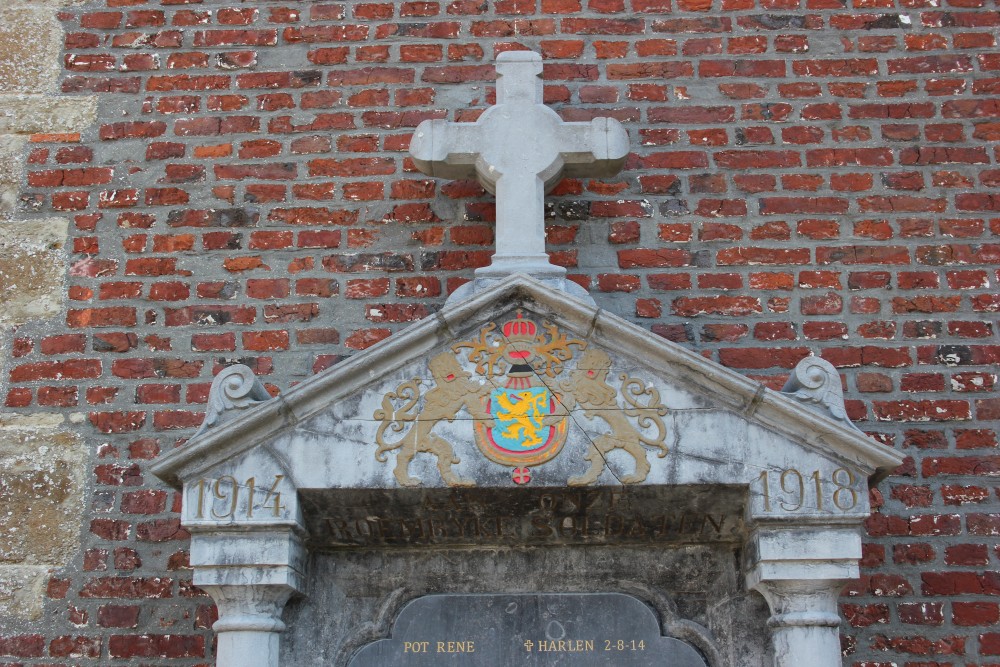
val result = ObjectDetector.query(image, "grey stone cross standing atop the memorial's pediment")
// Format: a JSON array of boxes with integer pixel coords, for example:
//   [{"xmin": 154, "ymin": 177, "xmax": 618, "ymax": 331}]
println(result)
[{"xmin": 410, "ymin": 51, "xmax": 629, "ymax": 300}]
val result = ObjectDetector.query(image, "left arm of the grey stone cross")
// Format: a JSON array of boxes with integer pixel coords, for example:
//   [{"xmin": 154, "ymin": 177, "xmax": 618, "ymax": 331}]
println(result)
[{"xmin": 410, "ymin": 119, "xmax": 481, "ymax": 179}]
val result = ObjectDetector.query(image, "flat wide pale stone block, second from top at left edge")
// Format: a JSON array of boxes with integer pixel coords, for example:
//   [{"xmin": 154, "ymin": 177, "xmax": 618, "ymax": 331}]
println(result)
[{"xmin": 0, "ymin": 94, "xmax": 97, "ymax": 134}]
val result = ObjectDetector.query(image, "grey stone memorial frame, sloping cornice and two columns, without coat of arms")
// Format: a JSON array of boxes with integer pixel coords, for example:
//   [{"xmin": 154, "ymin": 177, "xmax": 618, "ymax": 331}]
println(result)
[{"xmin": 154, "ymin": 275, "xmax": 902, "ymax": 667}]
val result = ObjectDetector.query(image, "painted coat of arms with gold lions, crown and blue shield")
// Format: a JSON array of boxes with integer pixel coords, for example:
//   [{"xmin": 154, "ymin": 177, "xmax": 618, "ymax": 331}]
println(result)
[{"xmin": 374, "ymin": 311, "xmax": 667, "ymax": 486}]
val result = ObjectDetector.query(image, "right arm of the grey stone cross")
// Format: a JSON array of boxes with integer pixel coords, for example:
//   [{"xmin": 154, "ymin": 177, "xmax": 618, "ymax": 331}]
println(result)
[{"xmin": 558, "ymin": 117, "xmax": 629, "ymax": 178}]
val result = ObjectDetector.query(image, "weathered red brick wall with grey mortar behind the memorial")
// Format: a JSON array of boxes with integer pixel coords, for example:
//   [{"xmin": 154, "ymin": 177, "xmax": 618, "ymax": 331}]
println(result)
[{"xmin": 0, "ymin": 0, "xmax": 1000, "ymax": 667}]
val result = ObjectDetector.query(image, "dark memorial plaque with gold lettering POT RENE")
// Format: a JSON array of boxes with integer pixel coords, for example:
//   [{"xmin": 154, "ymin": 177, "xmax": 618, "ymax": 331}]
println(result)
[{"xmin": 349, "ymin": 593, "xmax": 707, "ymax": 667}]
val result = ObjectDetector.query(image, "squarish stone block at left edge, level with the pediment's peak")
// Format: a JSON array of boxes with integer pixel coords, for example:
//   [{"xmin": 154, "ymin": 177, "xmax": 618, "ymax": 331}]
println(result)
[{"xmin": 0, "ymin": 218, "xmax": 69, "ymax": 326}]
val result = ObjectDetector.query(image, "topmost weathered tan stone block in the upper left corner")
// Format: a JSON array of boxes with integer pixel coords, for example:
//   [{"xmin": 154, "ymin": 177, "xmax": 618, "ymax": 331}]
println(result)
[{"xmin": 0, "ymin": 6, "xmax": 63, "ymax": 93}]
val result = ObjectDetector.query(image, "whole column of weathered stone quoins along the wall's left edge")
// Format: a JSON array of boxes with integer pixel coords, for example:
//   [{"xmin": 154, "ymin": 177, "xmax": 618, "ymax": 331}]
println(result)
[{"xmin": 0, "ymin": 0, "xmax": 97, "ymax": 619}]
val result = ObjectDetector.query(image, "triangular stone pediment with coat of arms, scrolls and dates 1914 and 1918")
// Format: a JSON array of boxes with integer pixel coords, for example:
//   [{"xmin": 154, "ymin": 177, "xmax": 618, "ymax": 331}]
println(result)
[{"xmin": 154, "ymin": 276, "xmax": 901, "ymax": 544}]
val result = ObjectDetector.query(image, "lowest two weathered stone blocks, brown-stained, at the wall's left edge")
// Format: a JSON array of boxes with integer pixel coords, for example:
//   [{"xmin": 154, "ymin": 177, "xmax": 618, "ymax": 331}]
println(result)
[{"xmin": 0, "ymin": 416, "xmax": 86, "ymax": 618}]
